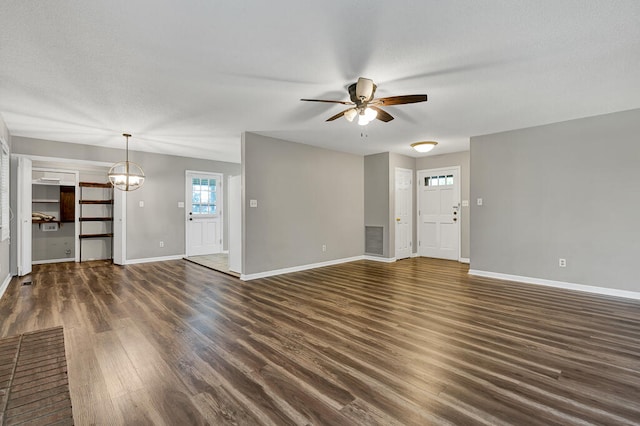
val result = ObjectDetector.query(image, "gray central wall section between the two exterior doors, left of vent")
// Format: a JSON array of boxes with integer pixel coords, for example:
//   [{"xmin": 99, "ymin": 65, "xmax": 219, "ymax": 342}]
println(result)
[{"xmin": 242, "ymin": 132, "xmax": 364, "ymax": 274}]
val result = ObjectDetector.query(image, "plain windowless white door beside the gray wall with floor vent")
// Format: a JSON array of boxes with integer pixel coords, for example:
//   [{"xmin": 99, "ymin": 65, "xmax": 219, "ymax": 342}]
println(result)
[{"xmin": 395, "ymin": 168, "xmax": 413, "ymax": 259}]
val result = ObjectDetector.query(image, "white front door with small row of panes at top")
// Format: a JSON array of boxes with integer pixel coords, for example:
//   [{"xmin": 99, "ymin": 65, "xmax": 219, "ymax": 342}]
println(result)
[{"xmin": 418, "ymin": 167, "xmax": 460, "ymax": 260}]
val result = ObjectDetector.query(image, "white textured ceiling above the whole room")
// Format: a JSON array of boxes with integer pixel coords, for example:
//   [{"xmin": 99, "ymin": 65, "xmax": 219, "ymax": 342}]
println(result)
[{"xmin": 0, "ymin": 0, "xmax": 640, "ymax": 162}]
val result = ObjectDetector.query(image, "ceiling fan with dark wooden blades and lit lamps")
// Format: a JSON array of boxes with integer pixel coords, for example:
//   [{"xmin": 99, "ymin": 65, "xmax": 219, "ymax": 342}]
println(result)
[{"xmin": 300, "ymin": 77, "xmax": 427, "ymax": 126}]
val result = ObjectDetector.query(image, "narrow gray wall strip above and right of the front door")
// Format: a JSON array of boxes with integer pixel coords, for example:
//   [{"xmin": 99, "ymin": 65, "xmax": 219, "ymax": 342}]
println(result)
[{"xmin": 416, "ymin": 151, "xmax": 471, "ymax": 259}]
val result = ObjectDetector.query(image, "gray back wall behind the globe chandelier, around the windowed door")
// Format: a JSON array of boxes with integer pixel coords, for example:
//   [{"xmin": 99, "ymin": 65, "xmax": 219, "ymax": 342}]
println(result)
[{"xmin": 12, "ymin": 137, "xmax": 240, "ymax": 260}]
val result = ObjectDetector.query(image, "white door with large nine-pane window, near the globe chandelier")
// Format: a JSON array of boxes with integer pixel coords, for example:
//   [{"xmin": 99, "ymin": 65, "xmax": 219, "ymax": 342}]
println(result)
[{"xmin": 185, "ymin": 171, "xmax": 223, "ymax": 256}]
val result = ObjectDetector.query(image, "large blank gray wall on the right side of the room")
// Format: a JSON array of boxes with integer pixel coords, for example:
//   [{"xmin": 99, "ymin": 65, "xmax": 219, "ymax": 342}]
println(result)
[{"xmin": 471, "ymin": 109, "xmax": 640, "ymax": 291}]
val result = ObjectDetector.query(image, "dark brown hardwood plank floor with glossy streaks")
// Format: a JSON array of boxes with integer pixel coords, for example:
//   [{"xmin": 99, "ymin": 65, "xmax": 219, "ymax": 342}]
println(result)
[{"xmin": 0, "ymin": 258, "xmax": 640, "ymax": 425}]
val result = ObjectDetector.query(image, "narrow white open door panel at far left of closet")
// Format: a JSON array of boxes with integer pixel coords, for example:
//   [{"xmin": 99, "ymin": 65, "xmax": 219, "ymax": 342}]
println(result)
[{"xmin": 18, "ymin": 157, "xmax": 33, "ymax": 277}]
